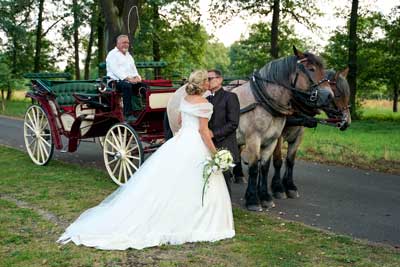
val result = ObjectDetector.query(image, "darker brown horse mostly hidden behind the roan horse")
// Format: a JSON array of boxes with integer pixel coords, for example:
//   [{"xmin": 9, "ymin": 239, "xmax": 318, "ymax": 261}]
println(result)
[{"xmin": 271, "ymin": 68, "xmax": 351, "ymax": 199}]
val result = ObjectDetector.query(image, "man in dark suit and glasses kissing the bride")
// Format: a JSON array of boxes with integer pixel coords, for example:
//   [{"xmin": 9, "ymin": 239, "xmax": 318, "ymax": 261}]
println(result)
[{"xmin": 207, "ymin": 70, "xmax": 243, "ymax": 193}]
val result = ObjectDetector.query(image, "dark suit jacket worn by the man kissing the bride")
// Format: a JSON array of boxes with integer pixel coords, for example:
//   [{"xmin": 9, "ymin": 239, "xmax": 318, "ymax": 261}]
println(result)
[{"xmin": 207, "ymin": 88, "xmax": 240, "ymax": 162}]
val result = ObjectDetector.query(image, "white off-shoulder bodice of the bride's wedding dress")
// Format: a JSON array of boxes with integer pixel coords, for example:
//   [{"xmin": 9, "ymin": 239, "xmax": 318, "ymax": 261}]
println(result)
[{"xmin": 179, "ymin": 99, "xmax": 213, "ymax": 130}]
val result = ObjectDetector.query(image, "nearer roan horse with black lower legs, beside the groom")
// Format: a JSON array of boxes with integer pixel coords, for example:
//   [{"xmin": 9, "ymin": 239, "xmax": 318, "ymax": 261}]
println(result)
[{"xmin": 232, "ymin": 47, "xmax": 334, "ymax": 211}]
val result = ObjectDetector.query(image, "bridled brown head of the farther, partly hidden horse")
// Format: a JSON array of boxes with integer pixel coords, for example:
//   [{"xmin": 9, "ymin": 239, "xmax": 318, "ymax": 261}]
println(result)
[{"xmin": 322, "ymin": 68, "xmax": 351, "ymax": 131}]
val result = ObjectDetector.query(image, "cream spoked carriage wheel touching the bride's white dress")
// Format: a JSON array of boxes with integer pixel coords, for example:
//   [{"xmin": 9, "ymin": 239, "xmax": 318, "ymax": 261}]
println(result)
[{"xmin": 103, "ymin": 123, "xmax": 143, "ymax": 185}]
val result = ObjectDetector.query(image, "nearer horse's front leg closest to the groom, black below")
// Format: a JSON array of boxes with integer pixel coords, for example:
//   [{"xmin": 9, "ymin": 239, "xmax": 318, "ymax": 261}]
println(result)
[{"xmin": 245, "ymin": 138, "xmax": 262, "ymax": 211}]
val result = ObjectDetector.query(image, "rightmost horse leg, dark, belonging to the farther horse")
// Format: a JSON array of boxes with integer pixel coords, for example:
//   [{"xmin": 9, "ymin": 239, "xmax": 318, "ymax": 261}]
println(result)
[{"xmin": 282, "ymin": 130, "xmax": 304, "ymax": 198}]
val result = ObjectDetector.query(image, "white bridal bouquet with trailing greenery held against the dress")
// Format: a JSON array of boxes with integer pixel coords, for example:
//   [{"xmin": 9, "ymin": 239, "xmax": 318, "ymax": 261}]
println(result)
[{"xmin": 201, "ymin": 149, "xmax": 235, "ymax": 205}]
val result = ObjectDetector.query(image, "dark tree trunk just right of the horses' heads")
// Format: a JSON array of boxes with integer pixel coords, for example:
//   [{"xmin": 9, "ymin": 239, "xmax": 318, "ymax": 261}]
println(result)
[{"xmin": 347, "ymin": 0, "xmax": 358, "ymax": 118}]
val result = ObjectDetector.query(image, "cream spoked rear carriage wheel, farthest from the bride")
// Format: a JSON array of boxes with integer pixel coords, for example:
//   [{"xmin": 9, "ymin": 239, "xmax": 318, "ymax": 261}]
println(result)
[{"xmin": 24, "ymin": 105, "xmax": 54, "ymax": 166}]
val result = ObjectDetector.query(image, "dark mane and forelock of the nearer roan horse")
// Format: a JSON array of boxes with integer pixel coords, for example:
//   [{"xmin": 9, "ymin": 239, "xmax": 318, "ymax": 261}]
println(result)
[{"xmin": 259, "ymin": 52, "xmax": 325, "ymax": 88}]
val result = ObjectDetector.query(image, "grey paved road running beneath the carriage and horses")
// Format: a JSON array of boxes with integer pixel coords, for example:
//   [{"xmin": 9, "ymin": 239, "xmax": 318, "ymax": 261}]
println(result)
[{"xmin": 0, "ymin": 117, "xmax": 400, "ymax": 248}]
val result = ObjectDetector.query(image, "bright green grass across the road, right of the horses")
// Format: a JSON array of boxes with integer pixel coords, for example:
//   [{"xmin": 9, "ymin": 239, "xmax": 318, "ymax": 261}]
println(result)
[{"xmin": 298, "ymin": 121, "xmax": 400, "ymax": 173}]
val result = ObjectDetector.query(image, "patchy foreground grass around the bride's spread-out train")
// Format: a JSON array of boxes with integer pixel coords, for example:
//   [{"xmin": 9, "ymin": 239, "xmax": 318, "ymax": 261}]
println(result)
[{"xmin": 0, "ymin": 146, "xmax": 400, "ymax": 267}]
